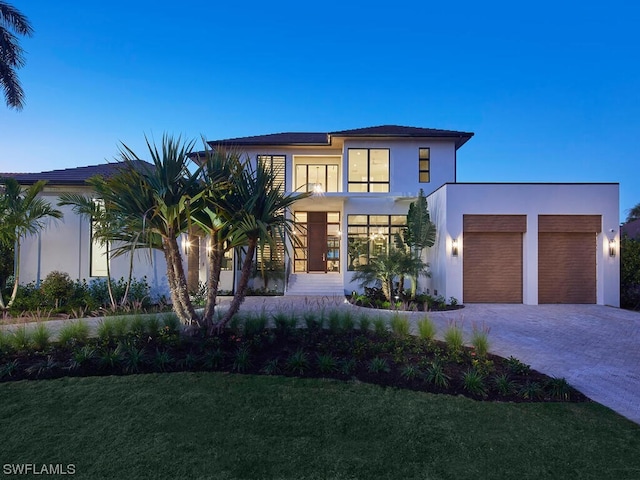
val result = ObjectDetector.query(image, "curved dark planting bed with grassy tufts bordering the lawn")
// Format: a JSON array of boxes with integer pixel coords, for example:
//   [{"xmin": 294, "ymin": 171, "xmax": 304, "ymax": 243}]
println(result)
[{"xmin": 0, "ymin": 311, "xmax": 587, "ymax": 402}]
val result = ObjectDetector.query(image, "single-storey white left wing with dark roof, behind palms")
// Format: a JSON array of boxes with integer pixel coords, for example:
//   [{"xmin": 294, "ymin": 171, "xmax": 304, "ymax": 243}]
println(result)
[{"xmin": 0, "ymin": 163, "xmax": 168, "ymax": 297}]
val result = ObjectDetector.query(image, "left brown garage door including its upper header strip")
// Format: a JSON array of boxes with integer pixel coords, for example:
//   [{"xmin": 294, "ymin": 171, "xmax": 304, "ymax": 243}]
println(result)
[{"xmin": 462, "ymin": 215, "xmax": 527, "ymax": 303}]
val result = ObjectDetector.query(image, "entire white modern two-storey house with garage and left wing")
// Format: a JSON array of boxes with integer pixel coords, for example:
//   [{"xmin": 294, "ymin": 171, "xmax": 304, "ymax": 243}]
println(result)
[{"xmin": 0, "ymin": 125, "xmax": 620, "ymax": 306}]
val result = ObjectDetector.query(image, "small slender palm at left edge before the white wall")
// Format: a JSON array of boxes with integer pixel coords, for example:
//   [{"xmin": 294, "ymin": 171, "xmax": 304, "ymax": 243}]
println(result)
[{"xmin": 0, "ymin": 178, "xmax": 62, "ymax": 309}]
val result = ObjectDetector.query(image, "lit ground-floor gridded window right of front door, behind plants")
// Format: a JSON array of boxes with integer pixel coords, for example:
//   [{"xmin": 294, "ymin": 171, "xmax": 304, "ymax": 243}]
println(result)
[{"xmin": 347, "ymin": 215, "xmax": 407, "ymax": 270}]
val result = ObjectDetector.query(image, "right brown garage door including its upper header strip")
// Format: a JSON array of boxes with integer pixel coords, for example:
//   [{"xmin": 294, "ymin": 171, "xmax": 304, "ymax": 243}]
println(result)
[{"xmin": 538, "ymin": 215, "xmax": 602, "ymax": 303}]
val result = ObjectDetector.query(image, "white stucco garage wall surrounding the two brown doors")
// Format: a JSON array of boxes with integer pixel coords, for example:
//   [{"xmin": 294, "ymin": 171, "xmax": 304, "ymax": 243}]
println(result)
[{"xmin": 428, "ymin": 183, "xmax": 620, "ymax": 307}]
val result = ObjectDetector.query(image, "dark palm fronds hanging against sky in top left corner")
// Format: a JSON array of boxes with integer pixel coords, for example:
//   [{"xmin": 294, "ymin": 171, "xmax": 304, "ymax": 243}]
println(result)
[{"xmin": 0, "ymin": 1, "xmax": 33, "ymax": 110}]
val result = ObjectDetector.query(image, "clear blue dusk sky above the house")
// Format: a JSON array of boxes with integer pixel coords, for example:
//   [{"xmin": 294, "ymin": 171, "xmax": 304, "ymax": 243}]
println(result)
[{"xmin": 0, "ymin": 0, "xmax": 640, "ymax": 221}]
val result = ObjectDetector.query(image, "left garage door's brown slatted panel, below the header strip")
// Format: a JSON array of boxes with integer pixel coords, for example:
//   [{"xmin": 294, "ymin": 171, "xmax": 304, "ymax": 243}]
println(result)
[{"xmin": 463, "ymin": 232, "xmax": 522, "ymax": 303}]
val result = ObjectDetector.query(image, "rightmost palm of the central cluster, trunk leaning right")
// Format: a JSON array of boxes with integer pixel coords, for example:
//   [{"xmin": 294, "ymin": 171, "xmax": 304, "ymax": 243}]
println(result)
[{"xmin": 211, "ymin": 158, "xmax": 311, "ymax": 331}]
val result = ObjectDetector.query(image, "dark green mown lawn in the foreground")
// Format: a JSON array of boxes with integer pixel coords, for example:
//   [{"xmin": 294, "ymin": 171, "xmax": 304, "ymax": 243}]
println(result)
[{"xmin": 0, "ymin": 373, "xmax": 640, "ymax": 480}]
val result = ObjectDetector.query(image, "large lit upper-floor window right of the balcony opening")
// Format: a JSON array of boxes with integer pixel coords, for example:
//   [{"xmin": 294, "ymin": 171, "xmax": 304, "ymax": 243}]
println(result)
[{"xmin": 348, "ymin": 148, "xmax": 389, "ymax": 192}]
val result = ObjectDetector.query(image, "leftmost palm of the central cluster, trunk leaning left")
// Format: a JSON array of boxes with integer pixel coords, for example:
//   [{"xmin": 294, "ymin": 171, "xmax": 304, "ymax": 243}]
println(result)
[{"xmin": 87, "ymin": 135, "xmax": 202, "ymax": 325}]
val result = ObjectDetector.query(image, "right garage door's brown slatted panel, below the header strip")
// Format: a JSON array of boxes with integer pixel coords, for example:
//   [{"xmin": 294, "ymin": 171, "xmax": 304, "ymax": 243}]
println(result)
[{"xmin": 538, "ymin": 232, "xmax": 596, "ymax": 303}]
